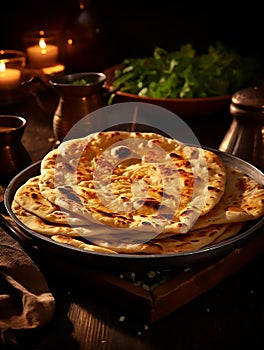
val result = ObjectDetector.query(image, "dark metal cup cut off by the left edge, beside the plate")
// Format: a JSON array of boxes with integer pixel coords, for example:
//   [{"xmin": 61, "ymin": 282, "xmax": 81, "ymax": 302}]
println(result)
[{"xmin": 0, "ymin": 115, "xmax": 32, "ymax": 185}]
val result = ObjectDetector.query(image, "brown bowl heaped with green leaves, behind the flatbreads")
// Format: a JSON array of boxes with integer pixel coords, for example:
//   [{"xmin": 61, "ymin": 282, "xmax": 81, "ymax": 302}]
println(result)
[{"xmin": 104, "ymin": 43, "xmax": 261, "ymax": 118}]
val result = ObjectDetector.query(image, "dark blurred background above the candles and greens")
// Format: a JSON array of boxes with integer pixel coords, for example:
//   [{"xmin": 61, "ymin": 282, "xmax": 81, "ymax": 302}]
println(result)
[{"xmin": 0, "ymin": 0, "xmax": 264, "ymax": 70}]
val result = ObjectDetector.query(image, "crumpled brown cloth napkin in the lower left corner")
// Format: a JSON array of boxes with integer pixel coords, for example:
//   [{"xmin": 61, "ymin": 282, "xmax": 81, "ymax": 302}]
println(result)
[{"xmin": 0, "ymin": 223, "xmax": 55, "ymax": 330}]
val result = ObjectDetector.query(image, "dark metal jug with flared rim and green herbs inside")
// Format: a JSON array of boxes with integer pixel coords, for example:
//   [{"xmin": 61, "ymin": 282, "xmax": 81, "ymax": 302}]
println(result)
[{"xmin": 49, "ymin": 72, "xmax": 106, "ymax": 141}]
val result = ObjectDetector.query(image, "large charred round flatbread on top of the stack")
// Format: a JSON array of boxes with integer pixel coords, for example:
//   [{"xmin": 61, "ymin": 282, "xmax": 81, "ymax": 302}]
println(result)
[{"xmin": 39, "ymin": 131, "xmax": 226, "ymax": 238}]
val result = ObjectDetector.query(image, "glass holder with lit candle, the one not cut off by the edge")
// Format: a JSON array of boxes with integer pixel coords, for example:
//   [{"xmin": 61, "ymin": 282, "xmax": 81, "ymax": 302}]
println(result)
[{"xmin": 23, "ymin": 30, "xmax": 64, "ymax": 71}]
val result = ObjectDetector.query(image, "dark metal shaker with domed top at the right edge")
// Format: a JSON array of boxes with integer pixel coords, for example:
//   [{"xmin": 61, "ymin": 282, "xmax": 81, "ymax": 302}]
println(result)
[{"xmin": 219, "ymin": 85, "xmax": 264, "ymax": 171}]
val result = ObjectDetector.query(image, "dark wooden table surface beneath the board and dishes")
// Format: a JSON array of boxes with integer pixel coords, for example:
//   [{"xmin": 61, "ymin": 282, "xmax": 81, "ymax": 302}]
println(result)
[{"xmin": 0, "ymin": 83, "xmax": 264, "ymax": 350}]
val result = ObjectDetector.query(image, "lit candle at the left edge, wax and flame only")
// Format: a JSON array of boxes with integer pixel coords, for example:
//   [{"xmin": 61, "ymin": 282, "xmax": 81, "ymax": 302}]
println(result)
[{"xmin": 0, "ymin": 61, "xmax": 21, "ymax": 91}]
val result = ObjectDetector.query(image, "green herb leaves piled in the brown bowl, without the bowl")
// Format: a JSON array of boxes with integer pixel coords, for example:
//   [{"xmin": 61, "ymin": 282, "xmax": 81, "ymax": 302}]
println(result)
[{"xmin": 113, "ymin": 42, "xmax": 261, "ymax": 98}]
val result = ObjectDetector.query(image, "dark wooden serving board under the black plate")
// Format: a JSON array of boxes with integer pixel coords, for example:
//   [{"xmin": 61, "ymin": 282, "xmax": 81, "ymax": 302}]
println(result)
[{"xmin": 39, "ymin": 224, "xmax": 264, "ymax": 323}]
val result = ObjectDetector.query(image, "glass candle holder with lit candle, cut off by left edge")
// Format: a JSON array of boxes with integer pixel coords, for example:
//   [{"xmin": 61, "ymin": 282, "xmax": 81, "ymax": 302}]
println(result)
[{"xmin": 0, "ymin": 50, "xmax": 26, "ymax": 104}]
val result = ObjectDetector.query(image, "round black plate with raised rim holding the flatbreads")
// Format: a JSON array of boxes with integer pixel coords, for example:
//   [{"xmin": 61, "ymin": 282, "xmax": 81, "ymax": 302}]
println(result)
[{"xmin": 4, "ymin": 148, "xmax": 264, "ymax": 271}]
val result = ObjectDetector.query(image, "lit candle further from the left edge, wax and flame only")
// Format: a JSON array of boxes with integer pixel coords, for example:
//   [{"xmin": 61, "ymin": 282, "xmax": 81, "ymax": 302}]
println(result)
[{"xmin": 27, "ymin": 38, "xmax": 59, "ymax": 68}]
